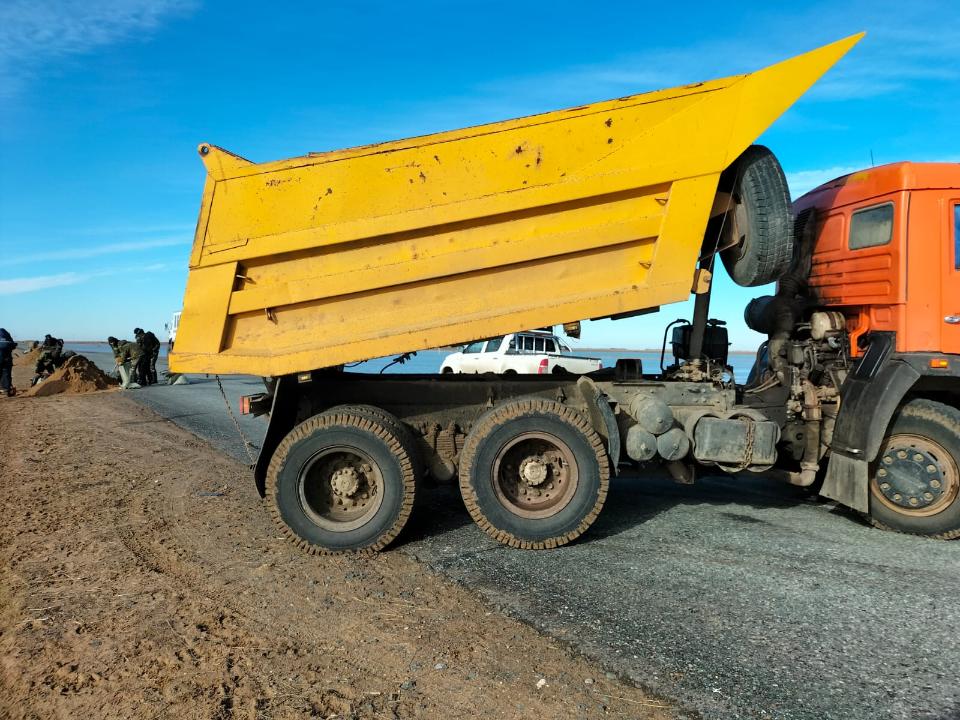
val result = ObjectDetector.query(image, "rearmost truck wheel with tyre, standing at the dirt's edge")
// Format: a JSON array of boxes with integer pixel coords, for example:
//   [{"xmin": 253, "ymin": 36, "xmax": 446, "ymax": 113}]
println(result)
[{"xmin": 266, "ymin": 412, "xmax": 416, "ymax": 555}]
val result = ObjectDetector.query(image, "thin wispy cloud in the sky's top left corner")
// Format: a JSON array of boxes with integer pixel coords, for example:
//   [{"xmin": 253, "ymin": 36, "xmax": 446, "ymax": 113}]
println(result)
[{"xmin": 0, "ymin": 0, "xmax": 195, "ymax": 96}]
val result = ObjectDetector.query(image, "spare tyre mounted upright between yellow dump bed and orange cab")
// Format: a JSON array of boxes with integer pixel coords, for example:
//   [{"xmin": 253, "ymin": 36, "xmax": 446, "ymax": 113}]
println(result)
[{"xmin": 719, "ymin": 145, "xmax": 794, "ymax": 287}]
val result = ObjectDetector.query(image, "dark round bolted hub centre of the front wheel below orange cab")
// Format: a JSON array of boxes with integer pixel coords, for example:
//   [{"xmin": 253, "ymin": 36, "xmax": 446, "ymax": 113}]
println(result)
[{"xmin": 877, "ymin": 447, "xmax": 946, "ymax": 510}]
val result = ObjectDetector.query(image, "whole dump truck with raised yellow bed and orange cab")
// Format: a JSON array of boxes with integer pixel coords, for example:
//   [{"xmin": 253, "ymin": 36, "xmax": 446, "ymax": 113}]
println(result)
[{"xmin": 170, "ymin": 31, "xmax": 960, "ymax": 553}]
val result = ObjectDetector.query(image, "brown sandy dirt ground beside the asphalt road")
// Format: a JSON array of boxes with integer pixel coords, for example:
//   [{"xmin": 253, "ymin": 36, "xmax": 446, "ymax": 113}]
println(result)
[{"xmin": 0, "ymin": 391, "xmax": 677, "ymax": 719}]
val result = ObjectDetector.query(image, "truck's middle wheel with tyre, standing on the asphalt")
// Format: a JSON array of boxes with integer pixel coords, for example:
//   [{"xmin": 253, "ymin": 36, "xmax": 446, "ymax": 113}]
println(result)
[{"xmin": 460, "ymin": 398, "xmax": 610, "ymax": 550}]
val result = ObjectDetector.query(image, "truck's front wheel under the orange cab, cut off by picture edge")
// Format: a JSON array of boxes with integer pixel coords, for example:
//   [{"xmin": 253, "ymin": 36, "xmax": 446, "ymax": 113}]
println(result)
[{"xmin": 870, "ymin": 399, "xmax": 960, "ymax": 540}]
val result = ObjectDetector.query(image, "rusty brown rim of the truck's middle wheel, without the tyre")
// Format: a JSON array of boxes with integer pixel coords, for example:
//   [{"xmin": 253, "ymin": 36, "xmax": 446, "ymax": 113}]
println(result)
[{"xmin": 492, "ymin": 432, "xmax": 579, "ymax": 518}]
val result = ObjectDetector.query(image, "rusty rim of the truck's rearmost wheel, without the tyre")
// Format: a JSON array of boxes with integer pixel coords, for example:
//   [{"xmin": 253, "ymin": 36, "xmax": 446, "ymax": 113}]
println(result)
[{"xmin": 297, "ymin": 445, "xmax": 383, "ymax": 532}]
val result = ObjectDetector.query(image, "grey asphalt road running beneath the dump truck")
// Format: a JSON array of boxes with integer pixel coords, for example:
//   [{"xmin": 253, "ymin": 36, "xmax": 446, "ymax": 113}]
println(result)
[{"xmin": 94, "ymin": 352, "xmax": 960, "ymax": 720}]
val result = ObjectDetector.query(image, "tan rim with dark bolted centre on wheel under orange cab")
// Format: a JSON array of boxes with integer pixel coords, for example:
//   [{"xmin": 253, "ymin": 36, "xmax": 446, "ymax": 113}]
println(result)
[{"xmin": 870, "ymin": 434, "xmax": 960, "ymax": 517}]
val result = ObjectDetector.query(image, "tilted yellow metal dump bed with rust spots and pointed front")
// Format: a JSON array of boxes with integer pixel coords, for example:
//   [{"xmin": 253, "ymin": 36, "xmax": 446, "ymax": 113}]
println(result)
[{"xmin": 170, "ymin": 36, "xmax": 859, "ymax": 375}]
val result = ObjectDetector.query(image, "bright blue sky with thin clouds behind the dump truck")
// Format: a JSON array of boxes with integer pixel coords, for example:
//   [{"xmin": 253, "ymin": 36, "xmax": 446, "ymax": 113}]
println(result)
[{"xmin": 0, "ymin": 0, "xmax": 960, "ymax": 349}]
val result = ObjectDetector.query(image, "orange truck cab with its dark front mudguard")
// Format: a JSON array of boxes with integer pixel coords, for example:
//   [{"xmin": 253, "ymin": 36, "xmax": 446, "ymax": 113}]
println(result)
[{"xmin": 794, "ymin": 162, "xmax": 960, "ymax": 529}]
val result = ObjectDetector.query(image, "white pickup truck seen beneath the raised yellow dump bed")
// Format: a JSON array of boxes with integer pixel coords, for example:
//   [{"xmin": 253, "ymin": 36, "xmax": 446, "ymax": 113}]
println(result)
[{"xmin": 440, "ymin": 330, "xmax": 603, "ymax": 375}]
